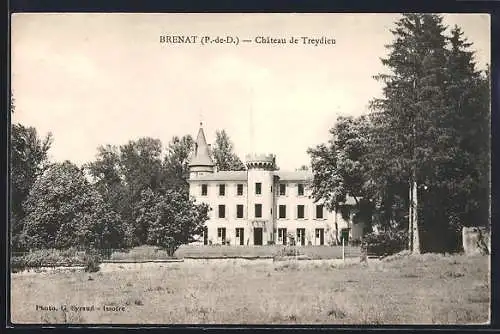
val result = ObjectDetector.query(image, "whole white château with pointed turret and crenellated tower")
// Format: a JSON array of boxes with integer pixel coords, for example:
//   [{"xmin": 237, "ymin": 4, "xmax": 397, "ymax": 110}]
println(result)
[{"xmin": 189, "ymin": 124, "xmax": 363, "ymax": 246}]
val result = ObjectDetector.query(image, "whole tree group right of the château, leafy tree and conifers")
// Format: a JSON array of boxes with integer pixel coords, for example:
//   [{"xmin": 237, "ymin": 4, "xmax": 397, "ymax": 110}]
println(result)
[{"xmin": 308, "ymin": 14, "xmax": 490, "ymax": 251}]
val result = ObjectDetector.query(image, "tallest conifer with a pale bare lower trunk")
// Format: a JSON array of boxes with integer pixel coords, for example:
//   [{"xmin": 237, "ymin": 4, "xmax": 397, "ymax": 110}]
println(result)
[{"xmin": 371, "ymin": 14, "xmax": 449, "ymax": 252}]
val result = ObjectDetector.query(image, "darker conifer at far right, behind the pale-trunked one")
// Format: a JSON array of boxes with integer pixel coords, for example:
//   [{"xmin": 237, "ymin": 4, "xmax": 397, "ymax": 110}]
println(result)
[{"xmin": 424, "ymin": 26, "xmax": 490, "ymax": 250}]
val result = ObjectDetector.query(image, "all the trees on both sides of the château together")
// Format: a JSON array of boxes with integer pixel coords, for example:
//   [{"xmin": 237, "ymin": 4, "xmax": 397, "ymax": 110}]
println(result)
[{"xmin": 10, "ymin": 14, "xmax": 490, "ymax": 252}]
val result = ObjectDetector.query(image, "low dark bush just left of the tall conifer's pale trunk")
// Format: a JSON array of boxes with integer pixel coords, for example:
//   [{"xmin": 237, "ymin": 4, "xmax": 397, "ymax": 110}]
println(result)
[{"xmin": 361, "ymin": 231, "xmax": 408, "ymax": 256}]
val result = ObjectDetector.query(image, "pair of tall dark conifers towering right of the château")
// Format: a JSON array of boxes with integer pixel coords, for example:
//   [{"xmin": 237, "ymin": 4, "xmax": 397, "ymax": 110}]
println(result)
[{"xmin": 370, "ymin": 14, "xmax": 489, "ymax": 251}]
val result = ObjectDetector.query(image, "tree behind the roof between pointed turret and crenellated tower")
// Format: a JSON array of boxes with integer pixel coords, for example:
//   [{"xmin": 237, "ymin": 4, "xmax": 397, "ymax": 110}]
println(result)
[{"xmin": 212, "ymin": 130, "xmax": 245, "ymax": 171}]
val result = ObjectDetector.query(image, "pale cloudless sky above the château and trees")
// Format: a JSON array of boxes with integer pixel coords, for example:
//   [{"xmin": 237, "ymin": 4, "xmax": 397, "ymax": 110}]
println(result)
[{"xmin": 11, "ymin": 13, "xmax": 490, "ymax": 170}]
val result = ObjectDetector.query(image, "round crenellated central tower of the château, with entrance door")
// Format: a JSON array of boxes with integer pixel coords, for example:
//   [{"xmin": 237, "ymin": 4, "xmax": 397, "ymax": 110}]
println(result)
[{"xmin": 246, "ymin": 154, "xmax": 276, "ymax": 245}]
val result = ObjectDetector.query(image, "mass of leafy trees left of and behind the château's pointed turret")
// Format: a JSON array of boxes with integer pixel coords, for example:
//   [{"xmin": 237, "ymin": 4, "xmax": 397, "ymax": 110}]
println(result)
[{"xmin": 10, "ymin": 116, "xmax": 244, "ymax": 254}]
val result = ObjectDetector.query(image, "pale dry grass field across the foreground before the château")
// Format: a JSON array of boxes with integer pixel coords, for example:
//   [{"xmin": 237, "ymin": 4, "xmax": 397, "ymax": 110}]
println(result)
[{"xmin": 11, "ymin": 254, "xmax": 490, "ymax": 324}]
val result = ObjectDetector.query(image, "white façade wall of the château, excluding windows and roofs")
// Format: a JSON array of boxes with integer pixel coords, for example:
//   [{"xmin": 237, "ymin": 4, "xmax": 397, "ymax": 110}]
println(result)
[{"xmin": 190, "ymin": 177, "xmax": 363, "ymax": 245}]
